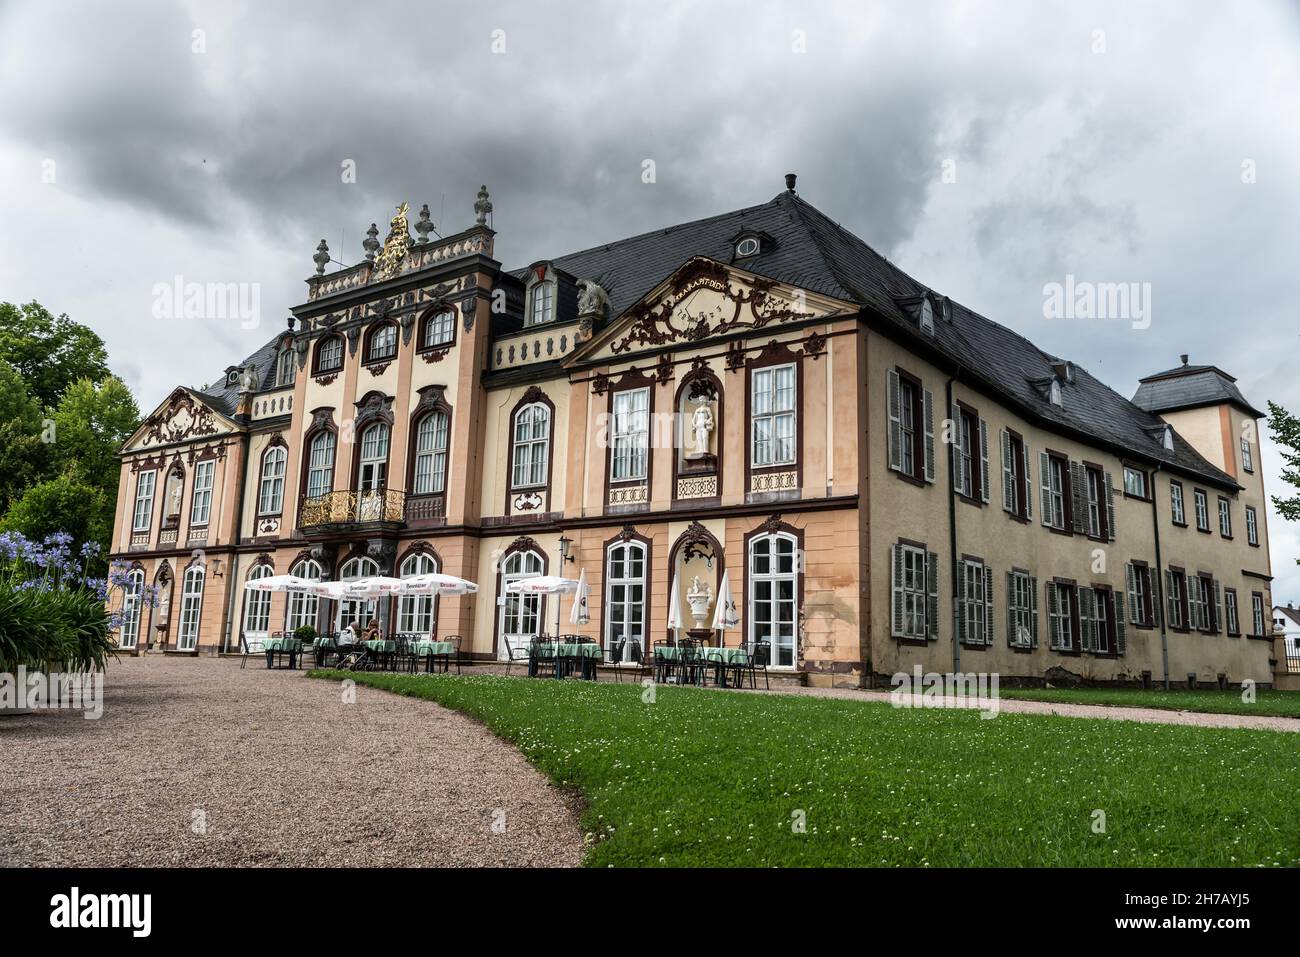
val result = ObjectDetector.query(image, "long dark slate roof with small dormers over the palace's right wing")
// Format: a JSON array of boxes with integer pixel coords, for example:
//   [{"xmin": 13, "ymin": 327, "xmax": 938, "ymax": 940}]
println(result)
[{"xmin": 514, "ymin": 191, "xmax": 1248, "ymax": 488}]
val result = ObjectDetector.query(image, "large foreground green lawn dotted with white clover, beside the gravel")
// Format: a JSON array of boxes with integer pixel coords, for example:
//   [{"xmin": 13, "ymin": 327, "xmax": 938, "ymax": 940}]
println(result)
[{"xmin": 312, "ymin": 671, "xmax": 1300, "ymax": 866}]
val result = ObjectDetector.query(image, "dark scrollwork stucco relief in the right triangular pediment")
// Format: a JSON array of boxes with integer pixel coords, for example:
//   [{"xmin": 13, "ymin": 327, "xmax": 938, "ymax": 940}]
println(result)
[{"xmin": 610, "ymin": 259, "xmax": 807, "ymax": 354}]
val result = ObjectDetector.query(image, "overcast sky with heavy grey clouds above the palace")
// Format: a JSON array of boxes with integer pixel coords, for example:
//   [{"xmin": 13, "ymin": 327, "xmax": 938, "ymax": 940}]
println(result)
[{"xmin": 0, "ymin": 0, "xmax": 1300, "ymax": 601}]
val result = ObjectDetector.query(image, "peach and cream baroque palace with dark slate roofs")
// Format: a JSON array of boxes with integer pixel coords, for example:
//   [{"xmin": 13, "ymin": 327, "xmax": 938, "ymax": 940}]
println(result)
[{"xmin": 113, "ymin": 176, "xmax": 1273, "ymax": 687}]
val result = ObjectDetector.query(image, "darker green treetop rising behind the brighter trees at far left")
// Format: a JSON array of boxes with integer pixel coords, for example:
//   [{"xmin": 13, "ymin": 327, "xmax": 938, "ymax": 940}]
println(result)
[{"xmin": 0, "ymin": 302, "xmax": 111, "ymax": 408}]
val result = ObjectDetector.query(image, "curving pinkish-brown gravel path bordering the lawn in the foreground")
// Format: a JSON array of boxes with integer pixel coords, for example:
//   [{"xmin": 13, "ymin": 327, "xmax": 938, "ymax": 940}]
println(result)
[{"xmin": 0, "ymin": 657, "xmax": 582, "ymax": 867}]
